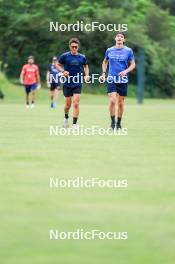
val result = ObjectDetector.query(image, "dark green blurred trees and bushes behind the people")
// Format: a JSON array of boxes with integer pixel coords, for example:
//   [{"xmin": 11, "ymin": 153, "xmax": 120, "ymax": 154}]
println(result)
[{"xmin": 0, "ymin": 0, "xmax": 175, "ymax": 96}]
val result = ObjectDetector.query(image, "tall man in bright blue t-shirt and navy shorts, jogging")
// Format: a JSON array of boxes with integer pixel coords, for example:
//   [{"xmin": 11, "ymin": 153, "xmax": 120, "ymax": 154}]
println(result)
[{"xmin": 102, "ymin": 32, "xmax": 135, "ymax": 129}]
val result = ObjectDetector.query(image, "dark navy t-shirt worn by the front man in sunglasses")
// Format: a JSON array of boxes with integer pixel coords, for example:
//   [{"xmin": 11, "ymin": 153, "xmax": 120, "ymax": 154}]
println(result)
[{"xmin": 58, "ymin": 51, "xmax": 87, "ymax": 87}]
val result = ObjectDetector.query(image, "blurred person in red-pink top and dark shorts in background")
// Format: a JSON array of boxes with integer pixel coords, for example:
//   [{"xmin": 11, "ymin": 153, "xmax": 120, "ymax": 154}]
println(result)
[{"xmin": 20, "ymin": 56, "xmax": 41, "ymax": 108}]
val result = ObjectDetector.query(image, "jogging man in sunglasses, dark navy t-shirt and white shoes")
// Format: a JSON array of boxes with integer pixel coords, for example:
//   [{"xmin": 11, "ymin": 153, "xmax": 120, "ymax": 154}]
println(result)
[{"xmin": 57, "ymin": 38, "xmax": 89, "ymax": 128}]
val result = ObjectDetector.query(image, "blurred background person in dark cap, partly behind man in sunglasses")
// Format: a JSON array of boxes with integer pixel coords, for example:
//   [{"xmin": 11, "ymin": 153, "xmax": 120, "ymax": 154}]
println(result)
[{"xmin": 46, "ymin": 56, "xmax": 60, "ymax": 108}]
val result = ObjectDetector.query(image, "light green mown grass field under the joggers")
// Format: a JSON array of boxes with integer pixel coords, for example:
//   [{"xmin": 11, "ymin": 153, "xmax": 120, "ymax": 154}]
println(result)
[{"xmin": 0, "ymin": 74, "xmax": 175, "ymax": 264}]
